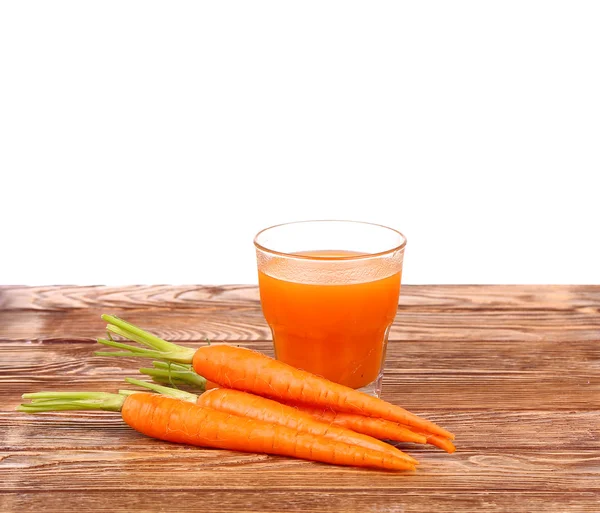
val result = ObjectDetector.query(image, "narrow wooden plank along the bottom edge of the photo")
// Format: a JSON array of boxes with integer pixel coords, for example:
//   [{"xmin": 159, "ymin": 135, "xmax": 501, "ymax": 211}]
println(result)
[{"xmin": 0, "ymin": 488, "xmax": 600, "ymax": 513}]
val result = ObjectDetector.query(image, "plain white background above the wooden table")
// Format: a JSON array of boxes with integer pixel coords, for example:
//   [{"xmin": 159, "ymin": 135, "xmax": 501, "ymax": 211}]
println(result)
[{"xmin": 0, "ymin": 0, "xmax": 600, "ymax": 284}]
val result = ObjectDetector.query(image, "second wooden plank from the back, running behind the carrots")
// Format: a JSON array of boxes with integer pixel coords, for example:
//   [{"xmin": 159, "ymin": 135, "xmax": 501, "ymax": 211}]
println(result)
[{"xmin": 0, "ymin": 341, "xmax": 600, "ymax": 414}]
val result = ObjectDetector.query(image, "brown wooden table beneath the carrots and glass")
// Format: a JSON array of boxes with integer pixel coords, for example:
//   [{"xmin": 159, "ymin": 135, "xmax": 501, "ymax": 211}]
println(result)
[{"xmin": 0, "ymin": 286, "xmax": 600, "ymax": 513}]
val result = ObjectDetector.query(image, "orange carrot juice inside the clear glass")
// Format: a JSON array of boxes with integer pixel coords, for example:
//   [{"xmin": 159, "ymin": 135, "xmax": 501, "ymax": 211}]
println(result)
[{"xmin": 259, "ymin": 251, "xmax": 401, "ymax": 389}]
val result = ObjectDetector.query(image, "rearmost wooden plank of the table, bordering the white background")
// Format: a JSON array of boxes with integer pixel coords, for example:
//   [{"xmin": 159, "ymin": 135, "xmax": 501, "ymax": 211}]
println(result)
[{"xmin": 0, "ymin": 286, "xmax": 600, "ymax": 342}]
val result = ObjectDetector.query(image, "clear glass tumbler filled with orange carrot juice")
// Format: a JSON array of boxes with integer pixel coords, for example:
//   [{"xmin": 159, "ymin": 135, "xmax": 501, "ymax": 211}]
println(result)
[{"xmin": 254, "ymin": 221, "xmax": 406, "ymax": 397}]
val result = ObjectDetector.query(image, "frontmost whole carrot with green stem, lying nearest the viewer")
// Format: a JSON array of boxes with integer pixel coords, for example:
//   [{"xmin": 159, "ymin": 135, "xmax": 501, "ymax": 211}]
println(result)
[{"xmin": 17, "ymin": 392, "xmax": 414, "ymax": 470}]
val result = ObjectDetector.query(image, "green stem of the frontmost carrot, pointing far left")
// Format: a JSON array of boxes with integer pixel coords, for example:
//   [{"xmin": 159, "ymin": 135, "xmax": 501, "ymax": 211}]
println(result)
[{"xmin": 17, "ymin": 392, "xmax": 125, "ymax": 413}]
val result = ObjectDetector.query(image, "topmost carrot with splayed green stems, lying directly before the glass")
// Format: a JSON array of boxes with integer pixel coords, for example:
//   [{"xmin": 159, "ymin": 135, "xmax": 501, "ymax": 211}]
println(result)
[{"xmin": 96, "ymin": 315, "xmax": 454, "ymax": 439}]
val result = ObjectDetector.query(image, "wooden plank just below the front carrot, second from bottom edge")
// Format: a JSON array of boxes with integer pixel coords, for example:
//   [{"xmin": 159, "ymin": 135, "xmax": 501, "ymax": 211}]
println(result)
[{"xmin": 0, "ymin": 448, "xmax": 600, "ymax": 493}]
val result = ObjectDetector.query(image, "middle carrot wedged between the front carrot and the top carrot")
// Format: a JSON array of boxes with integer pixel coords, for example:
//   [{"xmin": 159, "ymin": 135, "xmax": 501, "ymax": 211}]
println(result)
[{"xmin": 126, "ymin": 378, "xmax": 418, "ymax": 465}]
